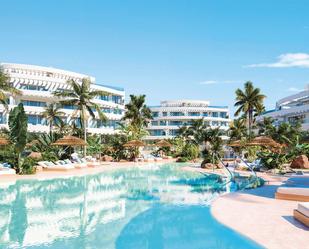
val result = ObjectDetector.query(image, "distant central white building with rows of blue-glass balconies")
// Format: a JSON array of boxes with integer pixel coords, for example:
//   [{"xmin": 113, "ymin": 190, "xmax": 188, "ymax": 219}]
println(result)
[{"xmin": 147, "ymin": 100, "xmax": 231, "ymax": 140}]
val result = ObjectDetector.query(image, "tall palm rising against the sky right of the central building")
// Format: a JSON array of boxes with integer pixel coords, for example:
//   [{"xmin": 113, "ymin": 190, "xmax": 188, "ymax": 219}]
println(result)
[{"xmin": 234, "ymin": 81, "xmax": 266, "ymax": 135}]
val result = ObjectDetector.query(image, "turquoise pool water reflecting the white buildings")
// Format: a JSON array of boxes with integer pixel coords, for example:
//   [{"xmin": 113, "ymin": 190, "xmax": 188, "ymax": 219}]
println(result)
[{"xmin": 0, "ymin": 164, "xmax": 261, "ymax": 249}]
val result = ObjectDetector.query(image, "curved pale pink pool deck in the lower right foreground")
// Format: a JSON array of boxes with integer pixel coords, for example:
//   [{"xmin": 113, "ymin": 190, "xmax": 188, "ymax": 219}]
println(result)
[{"xmin": 211, "ymin": 174, "xmax": 309, "ymax": 249}]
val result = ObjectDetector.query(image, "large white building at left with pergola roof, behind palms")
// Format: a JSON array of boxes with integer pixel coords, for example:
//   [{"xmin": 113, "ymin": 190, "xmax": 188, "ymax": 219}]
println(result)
[{"xmin": 0, "ymin": 63, "xmax": 125, "ymax": 134}]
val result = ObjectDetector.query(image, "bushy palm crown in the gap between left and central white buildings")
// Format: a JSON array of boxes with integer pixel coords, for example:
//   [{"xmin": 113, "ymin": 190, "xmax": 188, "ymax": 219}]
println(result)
[{"xmin": 122, "ymin": 95, "xmax": 152, "ymax": 129}]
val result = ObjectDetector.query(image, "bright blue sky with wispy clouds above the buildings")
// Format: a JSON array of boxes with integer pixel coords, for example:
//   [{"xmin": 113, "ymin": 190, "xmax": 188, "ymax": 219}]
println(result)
[{"xmin": 0, "ymin": 0, "xmax": 309, "ymax": 115}]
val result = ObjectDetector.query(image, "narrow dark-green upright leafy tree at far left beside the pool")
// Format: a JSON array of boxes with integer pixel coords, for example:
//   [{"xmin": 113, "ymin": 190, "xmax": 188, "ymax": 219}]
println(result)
[{"xmin": 9, "ymin": 103, "xmax": 28, "ymax": 172}]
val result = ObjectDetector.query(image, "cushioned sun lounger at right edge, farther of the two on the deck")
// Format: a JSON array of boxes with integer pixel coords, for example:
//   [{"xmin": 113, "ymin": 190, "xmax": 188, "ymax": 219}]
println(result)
[{"xmin": 275, "ymin": 187, "xmax": 309, "ymax": 202}]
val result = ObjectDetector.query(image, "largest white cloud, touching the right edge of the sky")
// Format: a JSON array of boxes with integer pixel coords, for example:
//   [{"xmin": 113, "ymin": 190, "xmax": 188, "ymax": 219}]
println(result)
[{"xmin": 247, "ymin": 53, "xmax": 309, "ymax": 68}]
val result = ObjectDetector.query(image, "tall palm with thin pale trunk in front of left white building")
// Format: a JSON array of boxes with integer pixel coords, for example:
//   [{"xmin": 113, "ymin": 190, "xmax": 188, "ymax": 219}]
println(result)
[{"xmin": 54, "ymin": 78, "xmax": 108, "ymax": 156}]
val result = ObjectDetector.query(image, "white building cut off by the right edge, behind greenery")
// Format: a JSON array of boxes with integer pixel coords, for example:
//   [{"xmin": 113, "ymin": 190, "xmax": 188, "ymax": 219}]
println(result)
[{"xmin": 257, "ymin": 86, "xmax": 309, "ymax": 130}]
